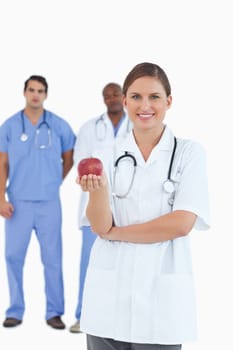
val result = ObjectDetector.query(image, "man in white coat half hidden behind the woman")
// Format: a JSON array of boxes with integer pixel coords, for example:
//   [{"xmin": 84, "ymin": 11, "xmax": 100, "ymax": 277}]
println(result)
[{"xmin": 70, "ymin": 82, "xmax": 131, "ymax": 333}]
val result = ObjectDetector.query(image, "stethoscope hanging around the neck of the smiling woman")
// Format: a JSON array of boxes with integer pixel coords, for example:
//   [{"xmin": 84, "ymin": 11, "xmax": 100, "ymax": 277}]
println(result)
[{"xmin": 112, "ymin": 136, "xmax": 177, "ymax": 201}]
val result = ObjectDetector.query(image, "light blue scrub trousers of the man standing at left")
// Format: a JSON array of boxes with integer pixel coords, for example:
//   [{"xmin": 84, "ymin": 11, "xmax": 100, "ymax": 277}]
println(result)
[{"xmin": 5, "ymin": 199, "xmax": 64, "ymax": 320}]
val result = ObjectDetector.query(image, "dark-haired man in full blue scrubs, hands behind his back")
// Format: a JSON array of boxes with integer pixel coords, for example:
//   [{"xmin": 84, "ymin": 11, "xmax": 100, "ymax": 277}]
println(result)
[{"xmin": 0, "ymin": 75, "xmax": 75, "ymax": 329}]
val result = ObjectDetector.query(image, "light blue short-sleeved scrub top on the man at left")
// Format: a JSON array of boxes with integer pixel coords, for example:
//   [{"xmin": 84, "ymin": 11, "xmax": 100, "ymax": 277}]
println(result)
[{"xmin": 0, "ymin": 111, "xmax": 76, "ymax": 200}]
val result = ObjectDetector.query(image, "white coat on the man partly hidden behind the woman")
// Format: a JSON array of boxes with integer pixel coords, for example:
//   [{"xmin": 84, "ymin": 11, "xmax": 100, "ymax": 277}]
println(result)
[{"xmin": 74, "ymin": 113, "xmax": 132, "ymax": 227}]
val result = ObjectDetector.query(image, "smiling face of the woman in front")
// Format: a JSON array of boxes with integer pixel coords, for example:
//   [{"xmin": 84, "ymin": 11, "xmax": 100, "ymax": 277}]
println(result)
[{"xmin": 124, "ymin": 76, "xmax": 172, "ymax": 130}]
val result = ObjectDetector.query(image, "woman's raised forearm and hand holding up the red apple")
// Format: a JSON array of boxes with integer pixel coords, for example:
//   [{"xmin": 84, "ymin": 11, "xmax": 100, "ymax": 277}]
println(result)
[{"xmin": 77, "ymin": 174, "xmax": 113, "ymax": 235}]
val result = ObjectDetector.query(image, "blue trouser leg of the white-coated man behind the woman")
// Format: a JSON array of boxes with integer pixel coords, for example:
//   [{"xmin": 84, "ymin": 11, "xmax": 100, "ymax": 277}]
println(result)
[{"xmin": 75, "ymin": 226, "xmax": 97, "ymax": 320}]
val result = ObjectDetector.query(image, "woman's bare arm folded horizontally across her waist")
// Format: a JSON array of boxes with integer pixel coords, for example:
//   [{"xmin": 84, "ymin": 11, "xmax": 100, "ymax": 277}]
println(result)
[{"xmin": 101, "ymin": 210, "xmax": 196, "ymax": 243}]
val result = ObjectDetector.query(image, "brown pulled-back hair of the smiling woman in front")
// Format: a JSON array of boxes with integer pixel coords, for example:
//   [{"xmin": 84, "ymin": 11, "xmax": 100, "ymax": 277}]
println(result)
[{"xmin": 122, "ymin": 62, "xmax": 171, "ymax": 96}]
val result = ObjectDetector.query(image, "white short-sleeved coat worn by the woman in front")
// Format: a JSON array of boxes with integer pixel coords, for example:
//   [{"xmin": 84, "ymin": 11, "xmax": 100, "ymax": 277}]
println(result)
[{"xmin": 81, "ymin": 127, "xmax": 209, "ymax": 344}]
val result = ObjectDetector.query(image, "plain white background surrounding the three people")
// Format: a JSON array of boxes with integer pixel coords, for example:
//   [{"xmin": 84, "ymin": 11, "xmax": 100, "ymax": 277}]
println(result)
[{"xmin": 0, "ymin": 0, "xmax": 233, "ymax": 350}]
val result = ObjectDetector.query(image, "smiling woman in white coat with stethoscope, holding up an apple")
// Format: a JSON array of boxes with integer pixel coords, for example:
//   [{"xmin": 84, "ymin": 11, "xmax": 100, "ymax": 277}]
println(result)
[{"xmin": 77, "ymin": 63, "xmax": 209, "ymax": 350}]
